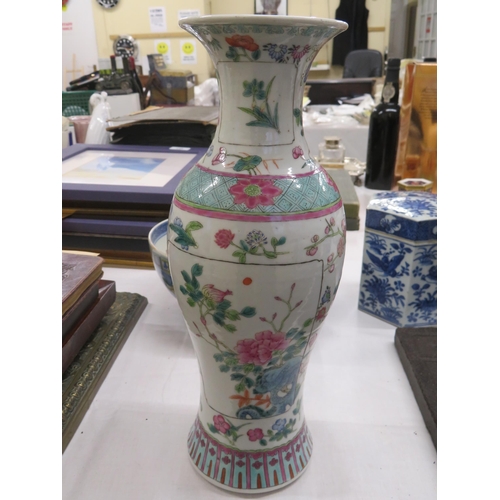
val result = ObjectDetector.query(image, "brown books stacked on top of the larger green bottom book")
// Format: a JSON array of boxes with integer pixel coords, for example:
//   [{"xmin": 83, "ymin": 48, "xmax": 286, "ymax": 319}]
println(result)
[{"xmin": 62, "ymin": 252, "xmax": 116, "ymax": 373}]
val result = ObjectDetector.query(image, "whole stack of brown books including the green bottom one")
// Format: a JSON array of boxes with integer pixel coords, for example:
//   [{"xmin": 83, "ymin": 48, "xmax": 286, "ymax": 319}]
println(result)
[{"xmin": 62, "ymin": 252, "xmax": 147, "ymax": 452}]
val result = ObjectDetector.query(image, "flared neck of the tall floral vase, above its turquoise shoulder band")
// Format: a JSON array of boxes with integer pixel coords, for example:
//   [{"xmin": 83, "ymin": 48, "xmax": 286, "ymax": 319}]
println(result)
[{"xmin": 180, "ymin": 16, "xmax": 347, "ymax": 175}]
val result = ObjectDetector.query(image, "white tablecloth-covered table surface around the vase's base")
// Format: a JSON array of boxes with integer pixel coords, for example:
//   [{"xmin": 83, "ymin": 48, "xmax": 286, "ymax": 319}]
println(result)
[{"xmin": 62, "ymin": 187, "xmax": 437, "ymax": 500}]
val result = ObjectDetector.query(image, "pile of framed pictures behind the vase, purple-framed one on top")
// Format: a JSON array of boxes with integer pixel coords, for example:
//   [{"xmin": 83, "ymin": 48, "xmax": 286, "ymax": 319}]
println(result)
[{"xmin": 62, "ymin": 143, "xmax": 207, "ymax": 269}]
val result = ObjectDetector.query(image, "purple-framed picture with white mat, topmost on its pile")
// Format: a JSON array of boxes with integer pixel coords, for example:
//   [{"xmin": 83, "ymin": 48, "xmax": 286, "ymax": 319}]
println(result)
[{"xmin": 62, "ymin": 144, "xmax": 206, "ymax": 210}]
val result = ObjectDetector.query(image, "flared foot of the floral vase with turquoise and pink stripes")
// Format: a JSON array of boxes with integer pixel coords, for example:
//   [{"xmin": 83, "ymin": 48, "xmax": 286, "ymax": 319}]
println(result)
[{"xmin": 188, "ymin": 418, "xmax": 312, "ymax": 493}]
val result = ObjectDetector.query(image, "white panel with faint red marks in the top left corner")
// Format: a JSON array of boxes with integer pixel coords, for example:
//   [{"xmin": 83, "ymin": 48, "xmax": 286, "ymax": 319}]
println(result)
[{"xmin": 62, "ymin": 0, "xmax": 98, "ymax": 90}]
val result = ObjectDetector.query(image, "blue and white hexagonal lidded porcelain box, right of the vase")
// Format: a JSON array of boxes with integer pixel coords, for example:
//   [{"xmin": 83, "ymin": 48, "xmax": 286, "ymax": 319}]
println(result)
[{"xmin": 358, "ymin": 191, "xmax": 437, "ymax": 327}]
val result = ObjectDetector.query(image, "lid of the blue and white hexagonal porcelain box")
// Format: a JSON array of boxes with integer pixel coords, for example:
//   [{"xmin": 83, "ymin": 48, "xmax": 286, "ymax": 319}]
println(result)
[{"xmin": 366, "ymin": 191, "xmax": 437, "ymax": 241}]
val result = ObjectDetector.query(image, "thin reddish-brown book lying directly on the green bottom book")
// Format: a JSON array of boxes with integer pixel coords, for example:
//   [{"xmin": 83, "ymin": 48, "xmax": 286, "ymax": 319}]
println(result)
[{"xmin": 62, "ymin": 280, "xmax": 116, "ymax": 373}]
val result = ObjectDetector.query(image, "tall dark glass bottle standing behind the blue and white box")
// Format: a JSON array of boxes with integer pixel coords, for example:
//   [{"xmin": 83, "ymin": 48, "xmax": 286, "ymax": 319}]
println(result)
[{"xmin": 365, "ymin": 59, "xmax": 401, "ymax": 191}]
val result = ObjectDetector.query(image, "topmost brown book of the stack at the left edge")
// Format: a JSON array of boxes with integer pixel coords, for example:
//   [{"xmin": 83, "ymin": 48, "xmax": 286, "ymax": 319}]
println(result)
[{"xmin": 62, "ymin": 252, "xmax": 104, "ymax": 315}]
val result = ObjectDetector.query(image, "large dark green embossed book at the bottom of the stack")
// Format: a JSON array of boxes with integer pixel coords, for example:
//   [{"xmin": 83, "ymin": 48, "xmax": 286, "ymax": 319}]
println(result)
[{"xmin": 62, "ymin": 292, "xmax": 148, "ymax": 452}]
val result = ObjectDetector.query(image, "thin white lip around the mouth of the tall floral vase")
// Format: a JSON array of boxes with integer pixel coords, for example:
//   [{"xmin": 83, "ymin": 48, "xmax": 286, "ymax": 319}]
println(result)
[{"xmin": 179, "ymin": 14, "xmax": 349, "ymax": 31}]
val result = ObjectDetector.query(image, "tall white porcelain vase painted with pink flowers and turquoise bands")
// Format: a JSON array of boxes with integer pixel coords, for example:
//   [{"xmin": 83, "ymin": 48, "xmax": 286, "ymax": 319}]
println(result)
[{"xmin": 167, "ymin": 15, "xmax": 347, "ymax": 493}]
